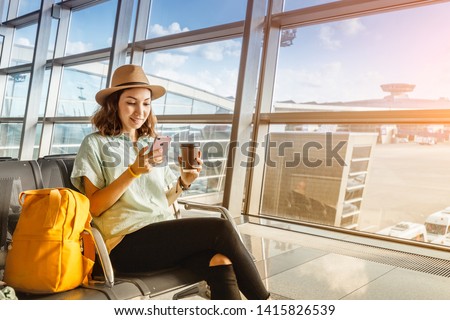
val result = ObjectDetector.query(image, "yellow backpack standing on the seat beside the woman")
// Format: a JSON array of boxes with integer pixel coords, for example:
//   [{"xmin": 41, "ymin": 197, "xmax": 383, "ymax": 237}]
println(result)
[{"xmin": 4, "ymin": 188, "xmax": 95, "ymax": 293}]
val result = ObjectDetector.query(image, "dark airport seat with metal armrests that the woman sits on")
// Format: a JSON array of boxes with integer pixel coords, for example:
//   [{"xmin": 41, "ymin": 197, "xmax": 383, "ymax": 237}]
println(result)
[{"xmin": 39, "ymin": 155, "xmax": 248, "ymax": 299}]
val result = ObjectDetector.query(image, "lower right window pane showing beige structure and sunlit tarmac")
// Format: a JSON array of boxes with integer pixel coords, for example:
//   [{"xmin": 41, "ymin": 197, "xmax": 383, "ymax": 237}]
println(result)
[{"xmin": 261, "ymin": 124, "xmax": 450, "ymax": 243}]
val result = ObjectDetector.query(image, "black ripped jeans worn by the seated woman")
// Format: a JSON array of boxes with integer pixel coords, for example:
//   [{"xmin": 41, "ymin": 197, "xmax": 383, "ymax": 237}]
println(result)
[{"xmin": 110, "ymin": 218, "xmax": 269, "ymax": 300}]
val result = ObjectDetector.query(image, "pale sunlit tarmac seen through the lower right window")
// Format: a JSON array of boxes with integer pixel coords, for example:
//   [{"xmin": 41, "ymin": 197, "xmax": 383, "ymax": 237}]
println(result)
[{"xmin": 358, "ymin": 142, "xmax": 450, "ymax": 232}]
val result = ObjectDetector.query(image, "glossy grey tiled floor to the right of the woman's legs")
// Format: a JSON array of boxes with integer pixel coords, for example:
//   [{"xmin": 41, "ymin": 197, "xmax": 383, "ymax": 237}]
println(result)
[{"xmin": 157, "ymin": 223, "xmax": 450, "ymax": 300}]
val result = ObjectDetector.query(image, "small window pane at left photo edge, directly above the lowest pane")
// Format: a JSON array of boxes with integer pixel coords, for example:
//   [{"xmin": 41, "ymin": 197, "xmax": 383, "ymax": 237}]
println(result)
[{"xmin": 1, "ymin": 73, "xmax": 30, "ymax": 117}]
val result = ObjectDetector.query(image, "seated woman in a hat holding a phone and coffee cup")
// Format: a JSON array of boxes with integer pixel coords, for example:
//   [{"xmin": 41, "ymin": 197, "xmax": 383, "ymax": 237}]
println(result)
[{"xmin": 72, "ymin": 65, "xmax": 269, "ymax": 299}]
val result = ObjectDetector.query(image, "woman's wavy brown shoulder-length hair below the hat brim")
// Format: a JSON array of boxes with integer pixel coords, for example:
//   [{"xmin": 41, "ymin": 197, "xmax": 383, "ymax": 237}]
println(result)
[{"xmin": 91, "ymin": 90, "xmax": 157, "ymax": 137}]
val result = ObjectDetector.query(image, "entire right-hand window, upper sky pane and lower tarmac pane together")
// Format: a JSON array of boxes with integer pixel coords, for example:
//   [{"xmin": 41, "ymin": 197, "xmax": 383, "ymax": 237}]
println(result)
[{"xmin": 260, "ymin": 3, "xmax": 450, "ymax": 245}]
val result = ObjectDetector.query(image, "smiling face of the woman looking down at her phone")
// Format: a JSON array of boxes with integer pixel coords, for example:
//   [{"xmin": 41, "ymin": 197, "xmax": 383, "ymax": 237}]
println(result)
[{"xmin": 119, "ymin": 88, "xmax": 152, "ymax": 134}]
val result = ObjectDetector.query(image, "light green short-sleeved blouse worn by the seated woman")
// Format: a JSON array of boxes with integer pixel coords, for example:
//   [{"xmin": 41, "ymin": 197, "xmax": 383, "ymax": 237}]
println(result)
[{"xmin": 71, "ymin": 133, "xmax": 176, "ymax": 241}]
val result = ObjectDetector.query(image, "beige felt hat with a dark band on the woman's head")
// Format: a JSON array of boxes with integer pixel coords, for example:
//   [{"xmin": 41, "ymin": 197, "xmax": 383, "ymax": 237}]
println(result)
[{"xmin": 95, "ymin": 64, "xmax": 166, "ymax": 105}]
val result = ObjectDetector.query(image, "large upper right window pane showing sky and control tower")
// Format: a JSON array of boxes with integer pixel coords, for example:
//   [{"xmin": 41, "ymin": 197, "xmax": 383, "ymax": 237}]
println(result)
[{"xmin": 273, "ymin": 2, "xmax": 450, "ymax": 112}]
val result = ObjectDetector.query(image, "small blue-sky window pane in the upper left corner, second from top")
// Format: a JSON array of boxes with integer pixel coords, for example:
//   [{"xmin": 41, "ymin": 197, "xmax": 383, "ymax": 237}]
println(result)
[{"xmin": 10, "ymin": 24, "xmax": 37, "ymax": 66}]
